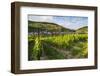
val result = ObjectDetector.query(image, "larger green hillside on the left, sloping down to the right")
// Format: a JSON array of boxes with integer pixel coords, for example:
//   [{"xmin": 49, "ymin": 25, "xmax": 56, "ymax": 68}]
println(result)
[{"xmin": 28, "ymin": 21, "xmax": 74, "ymax": 32}]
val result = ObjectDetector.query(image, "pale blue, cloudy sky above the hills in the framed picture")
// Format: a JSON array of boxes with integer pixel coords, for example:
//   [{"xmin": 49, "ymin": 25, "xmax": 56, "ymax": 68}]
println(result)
[{"xmin": 28, "ymin": 15, "xmax": 88, "ymax": 30}]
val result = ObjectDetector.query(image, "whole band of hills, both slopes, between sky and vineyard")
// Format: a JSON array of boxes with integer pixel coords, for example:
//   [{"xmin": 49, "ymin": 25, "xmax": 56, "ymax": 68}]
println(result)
[{"xmin": 28, "ymin": 21, "xmax": 88, "ymax": 34}]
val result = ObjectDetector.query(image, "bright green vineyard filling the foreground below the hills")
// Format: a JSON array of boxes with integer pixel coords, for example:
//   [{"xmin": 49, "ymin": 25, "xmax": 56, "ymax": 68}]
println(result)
[{"xmin": 28, "ymin": 34, "xmax": 88, "ymax": 60}]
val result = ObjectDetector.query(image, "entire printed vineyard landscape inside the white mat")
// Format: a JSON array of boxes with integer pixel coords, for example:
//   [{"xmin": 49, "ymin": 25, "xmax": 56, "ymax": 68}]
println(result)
[{"xmin": 28, "ymin": 15, "xmax": 88, "ymax": 61}]
